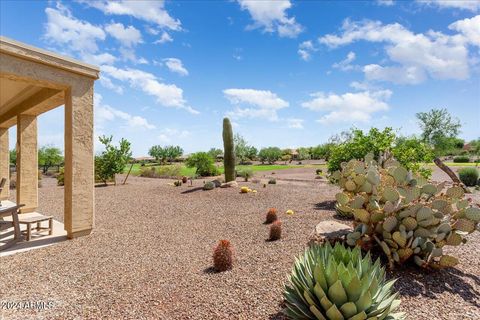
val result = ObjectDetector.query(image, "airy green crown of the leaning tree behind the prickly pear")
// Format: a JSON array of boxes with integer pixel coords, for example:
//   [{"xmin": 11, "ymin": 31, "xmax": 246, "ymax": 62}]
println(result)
[{"xmin": 416, "ymin": 109, "xmax": 462, "ymax": 155}]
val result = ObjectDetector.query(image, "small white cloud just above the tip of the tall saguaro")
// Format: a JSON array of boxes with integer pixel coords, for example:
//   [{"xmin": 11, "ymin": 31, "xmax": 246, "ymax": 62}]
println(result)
[{"xmin": 223, "ymin": 89, "xmax": 289, "ymax": 121}]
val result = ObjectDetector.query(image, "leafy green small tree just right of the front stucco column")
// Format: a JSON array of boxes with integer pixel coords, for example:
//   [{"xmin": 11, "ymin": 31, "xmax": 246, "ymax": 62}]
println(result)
[{"xmin": 95, "ymin": 136, "xmax": 132, "ymax": 185}]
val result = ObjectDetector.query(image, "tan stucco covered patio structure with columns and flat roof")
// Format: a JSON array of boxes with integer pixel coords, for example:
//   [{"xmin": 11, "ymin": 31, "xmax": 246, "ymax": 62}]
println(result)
[{"xmin": 0, "ymin": 37, "xmax": 99, "ymax": 250}]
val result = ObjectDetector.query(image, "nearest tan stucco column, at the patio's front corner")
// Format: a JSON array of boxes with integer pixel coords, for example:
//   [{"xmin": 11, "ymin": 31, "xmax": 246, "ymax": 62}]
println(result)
[{"xmin": 64, "ymin": 80, "xmax": 95, "ymax": 238}]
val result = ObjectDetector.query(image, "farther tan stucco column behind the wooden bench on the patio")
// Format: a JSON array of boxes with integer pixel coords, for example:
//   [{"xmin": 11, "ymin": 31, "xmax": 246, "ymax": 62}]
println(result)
[{"xmin": 16, "ymin": 115, "xmax": 38, "ymax": 212}]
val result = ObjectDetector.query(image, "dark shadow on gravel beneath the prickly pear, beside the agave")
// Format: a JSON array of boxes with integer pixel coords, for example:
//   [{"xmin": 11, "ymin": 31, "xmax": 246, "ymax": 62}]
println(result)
[{"xmin": 393, "ymin": 266, "xmax": 480, "ymax": 308}]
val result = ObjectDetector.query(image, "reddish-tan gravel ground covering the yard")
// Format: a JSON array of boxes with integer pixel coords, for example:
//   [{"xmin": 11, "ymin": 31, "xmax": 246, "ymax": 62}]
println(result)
[{"xmin": 0, "ymin": 169, "xmax": 480, "ymax": 319}]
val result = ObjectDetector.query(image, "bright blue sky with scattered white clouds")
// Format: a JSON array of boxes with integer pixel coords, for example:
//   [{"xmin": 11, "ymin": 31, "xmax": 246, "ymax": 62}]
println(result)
[{"xmin": 0, "ymin": 0, "xmax": 480, "ymax": 156}]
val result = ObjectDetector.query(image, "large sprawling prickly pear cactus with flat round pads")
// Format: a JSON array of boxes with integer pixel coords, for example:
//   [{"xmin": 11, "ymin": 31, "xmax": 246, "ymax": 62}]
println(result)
[{"xmin": 330, "ymin": 156, "xmax": 480, "ymax": 268}]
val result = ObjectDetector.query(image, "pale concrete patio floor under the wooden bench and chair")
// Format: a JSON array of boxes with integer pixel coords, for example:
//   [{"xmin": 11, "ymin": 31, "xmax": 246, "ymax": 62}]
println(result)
[{"xmin": 0, "ymin": 200, "xmax": 67, "ymax": 257}]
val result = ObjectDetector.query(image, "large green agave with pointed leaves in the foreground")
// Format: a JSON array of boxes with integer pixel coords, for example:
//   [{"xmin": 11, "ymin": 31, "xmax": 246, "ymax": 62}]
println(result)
[{"xmin": 284, "ymin": 243, "xmax": 405, "ymax": 320}]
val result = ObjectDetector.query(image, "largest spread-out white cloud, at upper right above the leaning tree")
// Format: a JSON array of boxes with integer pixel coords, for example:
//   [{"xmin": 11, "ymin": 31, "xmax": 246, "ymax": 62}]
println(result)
[{"xmin": 319, "ymin": 19, "xmax": 469, "ymax": 84}]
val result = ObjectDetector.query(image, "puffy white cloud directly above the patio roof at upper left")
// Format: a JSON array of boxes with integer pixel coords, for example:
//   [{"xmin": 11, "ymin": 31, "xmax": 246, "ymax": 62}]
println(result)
[{"xmin": 44, "ymin": 3, "xmax": 106, "ymax": 53}]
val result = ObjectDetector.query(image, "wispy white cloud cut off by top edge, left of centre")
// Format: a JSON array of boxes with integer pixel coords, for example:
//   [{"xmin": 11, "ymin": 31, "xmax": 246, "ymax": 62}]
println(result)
[{"xmin": 78, "ymin": 0, "xmax": 181, "ymax": 31}]
